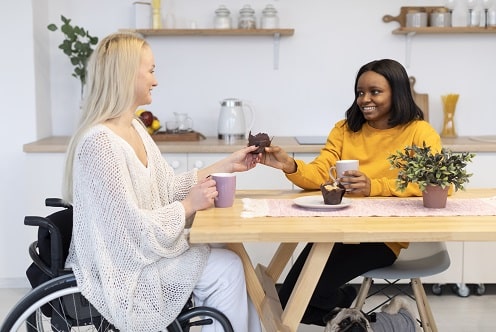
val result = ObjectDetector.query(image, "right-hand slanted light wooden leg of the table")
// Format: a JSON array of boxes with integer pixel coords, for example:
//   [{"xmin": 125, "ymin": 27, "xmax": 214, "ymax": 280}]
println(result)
[{"xmin": 282, "ymin": 243, "xmax": 334, "ymax": 332}]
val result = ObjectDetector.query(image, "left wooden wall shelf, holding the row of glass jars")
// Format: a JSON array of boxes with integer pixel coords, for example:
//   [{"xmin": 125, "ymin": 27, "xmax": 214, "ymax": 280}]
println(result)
[{"xmin": 125, "ymin": 29, "xmax": 294, "ymax": 37}]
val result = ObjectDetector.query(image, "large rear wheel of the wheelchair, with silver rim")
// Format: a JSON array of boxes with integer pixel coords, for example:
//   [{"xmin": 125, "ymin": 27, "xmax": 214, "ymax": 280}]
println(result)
[{"xmin": 0, "ymin": 274, "xmax": 117, "ymax": 332}]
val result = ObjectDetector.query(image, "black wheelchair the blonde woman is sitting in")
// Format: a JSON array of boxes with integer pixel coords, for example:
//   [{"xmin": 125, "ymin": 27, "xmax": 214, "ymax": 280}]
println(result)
[{"xmin": 0, "ymin": 198, "xmax": 234, "ymax": 332}]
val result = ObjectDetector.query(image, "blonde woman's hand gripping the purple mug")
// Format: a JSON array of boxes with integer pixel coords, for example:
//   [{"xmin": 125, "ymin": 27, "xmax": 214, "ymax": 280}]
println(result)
[{"xmin": 181, "ymin": 177, "xmax": 219, "ymax": 218}]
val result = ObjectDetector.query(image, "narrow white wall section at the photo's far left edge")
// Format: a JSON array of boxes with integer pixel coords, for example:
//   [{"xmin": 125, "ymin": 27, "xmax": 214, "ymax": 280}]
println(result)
[{"xmin": 0, "ymin": 1, "xmax": 36, "ymax": 287}]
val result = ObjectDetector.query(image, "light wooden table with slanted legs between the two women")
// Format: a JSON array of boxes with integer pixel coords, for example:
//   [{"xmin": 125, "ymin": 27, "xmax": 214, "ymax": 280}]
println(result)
[{"xmin": 190, "ymin": 189, "xmax": 496, "ymax": 332}]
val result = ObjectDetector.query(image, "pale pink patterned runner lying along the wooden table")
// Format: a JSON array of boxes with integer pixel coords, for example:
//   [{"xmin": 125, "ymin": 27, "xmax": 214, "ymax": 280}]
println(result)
[{"xmin": 241, "ymin": 196, "xmax": 496, "ymax": 218}]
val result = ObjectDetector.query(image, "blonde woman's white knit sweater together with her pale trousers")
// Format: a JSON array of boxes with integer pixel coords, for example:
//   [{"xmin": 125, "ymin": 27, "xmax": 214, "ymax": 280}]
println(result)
[{"xmin": 66, "ymin": 121, "xmax": 209, "ymax": 332}]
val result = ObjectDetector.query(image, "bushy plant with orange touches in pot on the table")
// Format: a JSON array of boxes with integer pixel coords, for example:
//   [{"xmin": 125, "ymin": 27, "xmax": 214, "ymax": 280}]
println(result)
[{"xmin": 388, "ymin": 142, "xmax": 475, "ymax": 208}]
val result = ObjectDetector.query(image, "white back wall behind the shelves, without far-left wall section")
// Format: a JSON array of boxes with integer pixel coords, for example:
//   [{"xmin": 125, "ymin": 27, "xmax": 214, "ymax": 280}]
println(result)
[{"xmin": 43, "ymin": 0, "xmax": 496, "ymax": 136}]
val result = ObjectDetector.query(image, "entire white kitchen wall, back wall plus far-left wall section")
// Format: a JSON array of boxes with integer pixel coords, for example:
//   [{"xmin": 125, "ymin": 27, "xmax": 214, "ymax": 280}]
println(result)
[{"xmin": 0, "ymin": 0, "xmax": 496, "ymax": 287}]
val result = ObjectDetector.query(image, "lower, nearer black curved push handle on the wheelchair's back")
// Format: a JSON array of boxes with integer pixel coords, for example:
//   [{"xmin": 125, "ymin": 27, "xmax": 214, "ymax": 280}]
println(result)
[{"xmin": 24, "ymin": 216, "xmax": 65, "ymax": 276}]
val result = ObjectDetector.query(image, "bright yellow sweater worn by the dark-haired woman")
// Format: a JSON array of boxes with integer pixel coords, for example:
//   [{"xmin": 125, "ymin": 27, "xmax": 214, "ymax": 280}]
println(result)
[{"xmin": 286, "ymin": 120, "xmax": 441, "ymax": 255}]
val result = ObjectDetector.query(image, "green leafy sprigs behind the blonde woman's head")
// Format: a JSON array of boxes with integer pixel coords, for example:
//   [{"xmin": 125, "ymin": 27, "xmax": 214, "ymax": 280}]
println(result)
[{"xmin": 47, "ymin": 15, "xmax": 98, "ymax": 96}]
